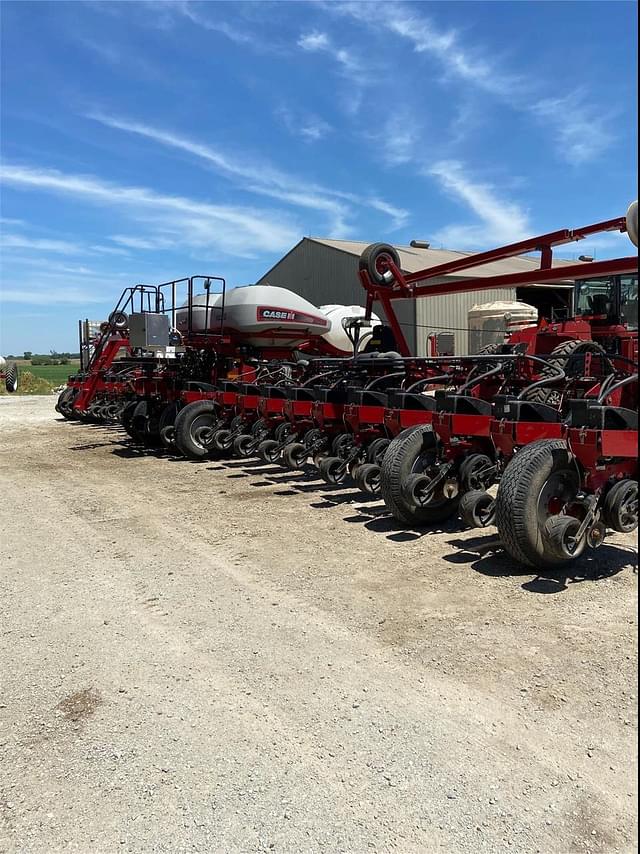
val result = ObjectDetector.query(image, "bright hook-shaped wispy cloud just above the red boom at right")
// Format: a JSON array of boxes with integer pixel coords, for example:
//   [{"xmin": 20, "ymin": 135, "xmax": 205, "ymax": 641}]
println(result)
[{"xmin": 425, "ymin": 160, "xmax": 531, "ymax": 249}]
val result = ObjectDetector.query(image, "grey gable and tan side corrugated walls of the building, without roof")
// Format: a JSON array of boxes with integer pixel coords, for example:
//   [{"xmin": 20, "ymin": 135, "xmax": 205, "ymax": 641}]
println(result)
[{"xmin": 256, "ymin": 238, "xmax": 515, "ymax": 356}]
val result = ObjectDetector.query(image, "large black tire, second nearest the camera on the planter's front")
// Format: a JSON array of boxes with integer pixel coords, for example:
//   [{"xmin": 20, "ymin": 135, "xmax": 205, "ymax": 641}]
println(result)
[{"xmin": 380, "ymin": 424, "xmax": 458, "ymax": 525}]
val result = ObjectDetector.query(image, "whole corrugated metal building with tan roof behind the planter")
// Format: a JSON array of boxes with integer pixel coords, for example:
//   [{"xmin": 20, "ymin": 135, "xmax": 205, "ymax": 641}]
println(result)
[{"xmin": 256, "ymin": 237, "xmax": 572, "ymax": 355}]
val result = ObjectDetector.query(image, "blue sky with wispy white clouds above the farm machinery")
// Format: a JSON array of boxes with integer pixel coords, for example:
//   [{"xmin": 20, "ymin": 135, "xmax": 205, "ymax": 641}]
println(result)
[{"xmin": 0, "ymin": 0, "xmax": 637, "ymax": 353}]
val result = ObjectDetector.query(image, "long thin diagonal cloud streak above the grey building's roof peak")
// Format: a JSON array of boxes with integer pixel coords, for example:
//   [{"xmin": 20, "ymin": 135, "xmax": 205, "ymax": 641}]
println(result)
[{"xmin": 89, "ymin": 112, "xmax": 406, "ymax": 237}]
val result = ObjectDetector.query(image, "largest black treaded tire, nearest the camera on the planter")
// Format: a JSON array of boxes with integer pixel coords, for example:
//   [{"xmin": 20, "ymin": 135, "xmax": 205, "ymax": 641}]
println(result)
[{"xmin": 496, "ymin": 439, "xmax": 580, "ymax": 568}]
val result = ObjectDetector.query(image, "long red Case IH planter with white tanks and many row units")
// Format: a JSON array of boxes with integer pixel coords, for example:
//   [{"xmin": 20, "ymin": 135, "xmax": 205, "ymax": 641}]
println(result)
[{"xmin": 58, "ymin": 203, "xmax": 638, "ymax": 566}]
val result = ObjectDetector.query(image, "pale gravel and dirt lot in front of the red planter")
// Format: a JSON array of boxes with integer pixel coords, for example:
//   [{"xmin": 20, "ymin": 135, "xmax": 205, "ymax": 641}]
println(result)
[{"xmin": 0, "ymin": 397, "xmax": 637, "ymax": 854}]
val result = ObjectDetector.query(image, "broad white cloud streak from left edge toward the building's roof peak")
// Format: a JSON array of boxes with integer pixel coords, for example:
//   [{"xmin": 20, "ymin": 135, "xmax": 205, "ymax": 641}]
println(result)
[{"xmin": 0, "ymin": 164, "xmax": 299, "ymax": 257}]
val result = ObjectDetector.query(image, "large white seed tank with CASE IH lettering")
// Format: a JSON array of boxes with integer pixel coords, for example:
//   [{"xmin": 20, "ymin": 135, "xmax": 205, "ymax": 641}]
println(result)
[{"xmin": 176, "ymin": 285, "xmax": 331, "ymax": 347}]
